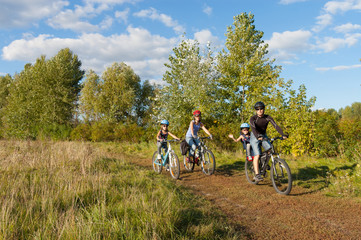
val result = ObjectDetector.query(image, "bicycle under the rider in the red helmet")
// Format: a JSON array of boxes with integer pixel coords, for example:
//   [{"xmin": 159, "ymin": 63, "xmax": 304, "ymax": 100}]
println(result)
[{"xmin": 183, "ymin": 137, "xmax": 216, "ymax": 175}]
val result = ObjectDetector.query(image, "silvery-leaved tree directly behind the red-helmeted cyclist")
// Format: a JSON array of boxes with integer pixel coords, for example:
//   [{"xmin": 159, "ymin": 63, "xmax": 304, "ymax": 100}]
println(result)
[{"xmin": 156, "ymin": 40, "xmax": 215, "ymax": 133}]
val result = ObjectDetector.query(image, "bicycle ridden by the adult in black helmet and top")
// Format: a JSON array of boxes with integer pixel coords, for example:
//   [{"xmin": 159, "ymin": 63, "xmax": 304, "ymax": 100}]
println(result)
[{"xmin": 244, "ymin": 137, "xmax": 292, "ymax": 195}]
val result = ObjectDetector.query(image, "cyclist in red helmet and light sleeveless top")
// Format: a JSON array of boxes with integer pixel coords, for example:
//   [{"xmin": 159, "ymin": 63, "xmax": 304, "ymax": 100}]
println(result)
[{"xmin": 186, "ymin": 110, "xmax": 212, "ymax": 165}]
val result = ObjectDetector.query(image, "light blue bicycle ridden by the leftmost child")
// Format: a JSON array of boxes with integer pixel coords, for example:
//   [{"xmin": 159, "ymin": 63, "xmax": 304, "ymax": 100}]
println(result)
[{"xmin": 152, "ymin": 139, "xmax": 180, "ymax": 179}]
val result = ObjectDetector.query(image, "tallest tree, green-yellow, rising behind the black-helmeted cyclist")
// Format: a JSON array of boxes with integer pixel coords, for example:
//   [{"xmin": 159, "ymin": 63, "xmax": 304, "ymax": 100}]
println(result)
[{"xmin": 217, "ymin": 13, "xmax": 291, "ymax": 123}]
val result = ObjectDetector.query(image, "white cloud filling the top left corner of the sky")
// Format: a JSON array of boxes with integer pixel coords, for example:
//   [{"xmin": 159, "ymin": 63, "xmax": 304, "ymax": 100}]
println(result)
[{"xmin": 0, "ymin": 0, "xmax": 69, "ymax": 28}]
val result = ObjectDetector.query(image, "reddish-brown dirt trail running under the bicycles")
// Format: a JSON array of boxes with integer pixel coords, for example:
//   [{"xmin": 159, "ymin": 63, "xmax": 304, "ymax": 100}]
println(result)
[{"xmin": 132, "ymin": 156, "xmax": 361, "ymax": 239}]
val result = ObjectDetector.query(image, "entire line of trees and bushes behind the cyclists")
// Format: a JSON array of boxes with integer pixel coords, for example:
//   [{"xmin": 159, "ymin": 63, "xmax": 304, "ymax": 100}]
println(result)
[{"xmin": 0, "ymin": 13, "xmax": 361, "ymax": 158}]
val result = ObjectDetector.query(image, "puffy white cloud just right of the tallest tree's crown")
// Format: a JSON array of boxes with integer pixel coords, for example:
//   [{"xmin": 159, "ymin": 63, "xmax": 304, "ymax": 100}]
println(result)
[{"xmin": 265, "ymin": 30, "xmax": 312, "ymax": 60}]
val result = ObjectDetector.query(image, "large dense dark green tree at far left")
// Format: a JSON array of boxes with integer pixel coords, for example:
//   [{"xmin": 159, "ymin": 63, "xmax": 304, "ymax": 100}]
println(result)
[{"xmin": 3, "ymin": 48, "xmax": 84, "ymax": 138}]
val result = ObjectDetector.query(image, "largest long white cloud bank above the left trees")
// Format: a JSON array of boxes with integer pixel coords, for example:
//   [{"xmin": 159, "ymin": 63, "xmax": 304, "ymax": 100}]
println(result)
[{"xmin": 2, "ymin": 26, "xmax": 179, "ymax": 79}]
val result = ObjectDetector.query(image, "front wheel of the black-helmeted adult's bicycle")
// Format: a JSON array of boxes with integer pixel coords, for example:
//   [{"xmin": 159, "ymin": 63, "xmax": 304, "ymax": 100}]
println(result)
[{"xmin": 271, "ymin": 158, "xmax": 292, "ymax": 195}]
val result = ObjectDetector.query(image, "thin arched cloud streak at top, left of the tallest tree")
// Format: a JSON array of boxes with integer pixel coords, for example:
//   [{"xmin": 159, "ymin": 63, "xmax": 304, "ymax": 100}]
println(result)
[{"xmin": 133, "ymin": 8, "xmax": 185, "ymax": 34}]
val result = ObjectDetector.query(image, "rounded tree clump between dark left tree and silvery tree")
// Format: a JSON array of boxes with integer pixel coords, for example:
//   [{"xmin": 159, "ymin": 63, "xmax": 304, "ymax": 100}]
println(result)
[{"xmin": 80, "ymin": 63, "xmax": 153, "ymax": 124}]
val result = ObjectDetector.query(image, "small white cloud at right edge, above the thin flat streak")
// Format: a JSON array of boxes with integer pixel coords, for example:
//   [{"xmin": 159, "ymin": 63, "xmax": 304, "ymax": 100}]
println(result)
[{"xmin": 317, "ymin": 33, "xmax": 361, "ymax": 52}]
